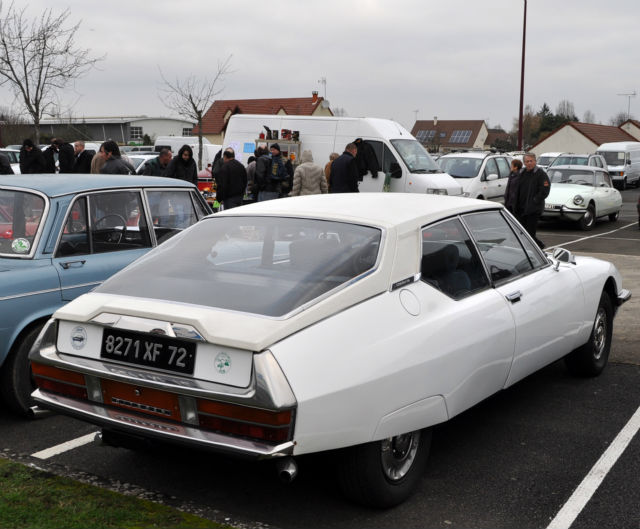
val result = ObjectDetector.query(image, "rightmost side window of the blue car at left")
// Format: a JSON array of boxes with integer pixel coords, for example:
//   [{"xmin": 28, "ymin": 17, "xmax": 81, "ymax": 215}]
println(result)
[{"xmin": 147, "ymin": 189, "xmax": 198, "ymax": 244}]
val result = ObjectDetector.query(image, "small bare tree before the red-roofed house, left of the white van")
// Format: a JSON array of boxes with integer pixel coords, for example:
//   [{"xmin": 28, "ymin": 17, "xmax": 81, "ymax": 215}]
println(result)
[{"xmin": 160, "ymin": 55, "xmax": 231, "ymax": 169}]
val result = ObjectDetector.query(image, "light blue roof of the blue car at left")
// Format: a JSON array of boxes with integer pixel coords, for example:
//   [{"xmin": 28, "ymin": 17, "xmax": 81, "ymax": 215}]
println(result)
[{"xmin": 0, "ymin": 174, "xmax": 193, "ymax": 197}]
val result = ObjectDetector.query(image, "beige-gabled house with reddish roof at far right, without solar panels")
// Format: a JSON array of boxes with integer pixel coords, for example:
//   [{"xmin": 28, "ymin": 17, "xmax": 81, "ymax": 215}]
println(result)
[{"xmin": 529, "ymin": 121, "xmax": 638, "ymax": 156}]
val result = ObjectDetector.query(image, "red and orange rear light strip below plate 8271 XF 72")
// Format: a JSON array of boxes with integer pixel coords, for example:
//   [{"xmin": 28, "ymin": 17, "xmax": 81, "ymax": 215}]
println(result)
[{"xmin": 32, "ymin": 362, "xmax": 293, "ymax": 443}]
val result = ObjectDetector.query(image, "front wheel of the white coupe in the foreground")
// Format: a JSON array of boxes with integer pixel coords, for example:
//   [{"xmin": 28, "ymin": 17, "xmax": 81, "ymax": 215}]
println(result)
[{"xmin": 564, "ymin": 292, "xmax": 613, "ymax": 377}]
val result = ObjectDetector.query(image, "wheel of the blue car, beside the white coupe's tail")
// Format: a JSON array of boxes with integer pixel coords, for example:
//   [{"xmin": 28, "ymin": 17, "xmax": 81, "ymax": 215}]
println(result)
[{"xmin": 0, "ymin": 324, "xmax": 42, "ymax": 417}]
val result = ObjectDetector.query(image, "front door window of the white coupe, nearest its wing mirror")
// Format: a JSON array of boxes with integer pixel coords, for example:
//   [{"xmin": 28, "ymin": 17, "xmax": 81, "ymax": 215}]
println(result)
[{"xmin": 463, "ymin": 211, "xmax": 544, "ymax": 282}]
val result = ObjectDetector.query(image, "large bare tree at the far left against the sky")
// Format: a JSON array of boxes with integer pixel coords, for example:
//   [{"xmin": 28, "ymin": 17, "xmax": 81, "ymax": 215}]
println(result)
[{"xmin": 0, "ymin": 0, "xmax": 103, "ymax": 143}]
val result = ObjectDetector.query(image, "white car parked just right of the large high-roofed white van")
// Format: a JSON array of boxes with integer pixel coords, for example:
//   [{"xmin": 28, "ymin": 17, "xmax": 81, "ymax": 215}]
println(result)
[{"xmin": 438, "ymin": 152, "xmax": 511, "ymax": 202}]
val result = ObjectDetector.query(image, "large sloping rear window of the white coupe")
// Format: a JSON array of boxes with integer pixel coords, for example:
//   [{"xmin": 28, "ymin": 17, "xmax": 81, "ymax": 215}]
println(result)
[{"xmin": 96, "ymin": 216, "xmax": 382, "ymax": 317}]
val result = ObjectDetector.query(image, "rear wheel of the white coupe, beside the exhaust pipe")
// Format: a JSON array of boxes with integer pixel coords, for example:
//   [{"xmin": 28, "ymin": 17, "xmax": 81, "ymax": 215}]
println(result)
[{"xmin": 338, "ymin": 429, "xmax": 431, "ymax": 508}]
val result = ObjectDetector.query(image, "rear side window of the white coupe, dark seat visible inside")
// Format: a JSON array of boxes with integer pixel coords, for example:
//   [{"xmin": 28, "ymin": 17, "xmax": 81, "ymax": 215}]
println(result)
[{"xmin": 420, "ymin": 214, "xmax": 489, "ymax": 299}]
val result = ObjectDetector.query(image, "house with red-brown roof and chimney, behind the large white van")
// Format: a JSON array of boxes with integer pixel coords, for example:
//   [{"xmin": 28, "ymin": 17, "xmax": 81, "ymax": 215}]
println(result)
[{"xmin": 193, "ymin": 91, "xmax": 333, "ymax": 145}]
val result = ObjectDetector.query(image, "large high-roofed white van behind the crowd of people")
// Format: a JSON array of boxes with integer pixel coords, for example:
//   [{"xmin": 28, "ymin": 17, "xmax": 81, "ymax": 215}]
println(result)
[{"xmin": 224, "ymin": 114, "xmax": 462, "ymax": 195}]
